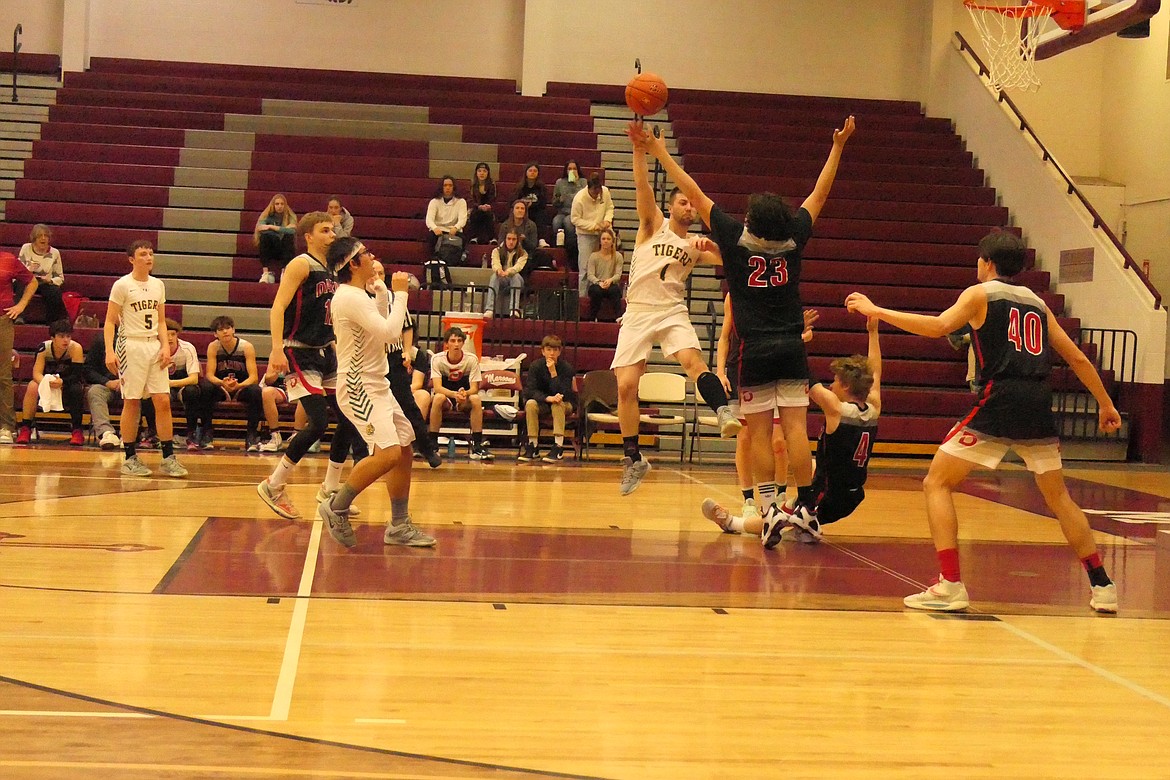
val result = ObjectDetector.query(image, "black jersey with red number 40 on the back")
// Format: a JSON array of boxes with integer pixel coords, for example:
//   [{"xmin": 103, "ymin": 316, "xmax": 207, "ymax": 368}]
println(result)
[{"xmin": 971, "ymin": 279, "xmax": 1051, "ymax": 382}]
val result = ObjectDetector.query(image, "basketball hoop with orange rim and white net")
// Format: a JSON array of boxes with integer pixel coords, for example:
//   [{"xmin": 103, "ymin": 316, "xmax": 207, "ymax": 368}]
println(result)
[{"xmin": 963, "ymin": 0, "xmax": 1086, "ymax": 91}]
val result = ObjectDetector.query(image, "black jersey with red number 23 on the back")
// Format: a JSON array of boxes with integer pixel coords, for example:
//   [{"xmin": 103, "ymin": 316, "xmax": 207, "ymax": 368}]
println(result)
[{"xmin": 710, "ymin": 206, "xmax": 812, "ymax": 340}]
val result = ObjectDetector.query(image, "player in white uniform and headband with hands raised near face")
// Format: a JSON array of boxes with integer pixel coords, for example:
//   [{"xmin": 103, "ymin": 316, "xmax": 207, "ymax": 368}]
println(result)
[{"xmin": 317, "ymin": 236, "xmax": 435, "ymax": 547}]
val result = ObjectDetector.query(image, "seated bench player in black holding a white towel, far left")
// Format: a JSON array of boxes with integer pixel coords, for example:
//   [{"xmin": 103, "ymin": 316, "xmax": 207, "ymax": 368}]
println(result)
[{"xmin": 16, "ymin": 319, "xmax": 85, "ymax": 447}]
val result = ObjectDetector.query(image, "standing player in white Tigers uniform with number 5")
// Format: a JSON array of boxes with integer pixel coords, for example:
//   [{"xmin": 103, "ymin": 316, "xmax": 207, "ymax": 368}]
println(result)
[{"xmin": 105, "ymin": 240, "xmax": 187, "ymax": 477}]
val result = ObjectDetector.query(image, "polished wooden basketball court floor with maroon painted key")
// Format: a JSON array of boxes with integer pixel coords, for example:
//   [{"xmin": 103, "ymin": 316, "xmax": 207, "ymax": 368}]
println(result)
[{"xmin": 0, "ymin": 447, "xmax": 1170, "ymax": 779}]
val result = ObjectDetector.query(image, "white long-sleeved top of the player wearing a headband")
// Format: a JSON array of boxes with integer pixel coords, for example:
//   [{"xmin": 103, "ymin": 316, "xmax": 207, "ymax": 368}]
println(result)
[{"xmin": 332, "ymin": 284, "xmax": 407, "ymax": 398}]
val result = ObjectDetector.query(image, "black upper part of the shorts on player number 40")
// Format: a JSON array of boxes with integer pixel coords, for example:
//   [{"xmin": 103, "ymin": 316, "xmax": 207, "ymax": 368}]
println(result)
[{"xmin": 961, "ymin": 379, "xmax": 1057, "ymax": 441}]
